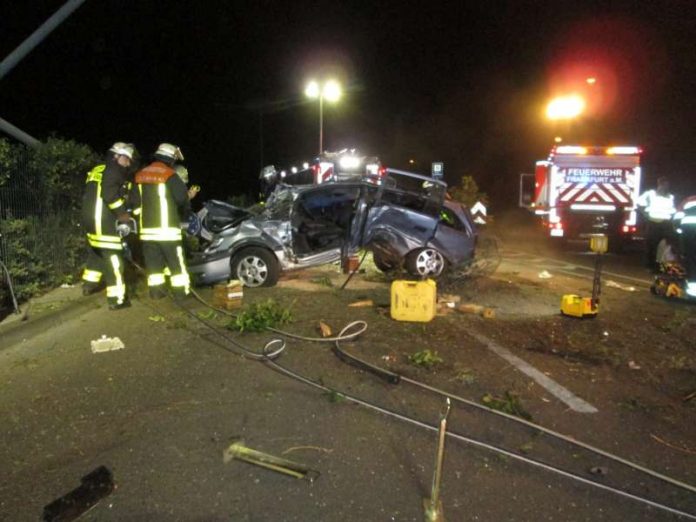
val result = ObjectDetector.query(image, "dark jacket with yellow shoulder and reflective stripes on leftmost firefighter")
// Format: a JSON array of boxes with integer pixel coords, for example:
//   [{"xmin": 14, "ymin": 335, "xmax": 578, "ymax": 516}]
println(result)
[{"xmin": 82, "ymin": 160, "xmax": 128, "ymax": 250}]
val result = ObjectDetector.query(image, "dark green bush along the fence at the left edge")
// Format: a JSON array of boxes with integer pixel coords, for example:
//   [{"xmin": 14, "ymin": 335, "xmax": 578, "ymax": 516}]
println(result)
[{"xmin": 0, "ymin": 138, "xmax": 99, "ymax": 309}]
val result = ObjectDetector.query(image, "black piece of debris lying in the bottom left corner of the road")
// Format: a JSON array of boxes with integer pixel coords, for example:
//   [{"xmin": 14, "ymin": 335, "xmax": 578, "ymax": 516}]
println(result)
[{"xmin": 41, "ymin": 466, "xmax": 116, "ymax": 522}]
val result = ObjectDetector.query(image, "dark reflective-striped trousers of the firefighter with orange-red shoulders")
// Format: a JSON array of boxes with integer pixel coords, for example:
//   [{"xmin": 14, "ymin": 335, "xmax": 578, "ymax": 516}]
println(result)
[{"xmin": 142, "ymin": 241, "xmax": 191, "ymax": 296}]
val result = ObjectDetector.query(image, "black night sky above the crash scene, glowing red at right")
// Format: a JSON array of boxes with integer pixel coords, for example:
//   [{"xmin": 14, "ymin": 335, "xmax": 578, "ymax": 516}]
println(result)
[{"xmin": 0, "ymin": 0, "xmax": 696, "ymax": 207}]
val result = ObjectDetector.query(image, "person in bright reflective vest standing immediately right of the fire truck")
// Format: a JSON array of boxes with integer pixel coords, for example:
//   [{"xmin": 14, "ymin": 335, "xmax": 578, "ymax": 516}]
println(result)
[{"xmin": 636, "ymin": 177, "xmax": 676, "ymax": 272}]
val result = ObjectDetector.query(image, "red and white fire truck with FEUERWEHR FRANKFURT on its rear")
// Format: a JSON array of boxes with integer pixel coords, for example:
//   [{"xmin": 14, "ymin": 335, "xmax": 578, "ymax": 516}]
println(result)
[{"xmin": 520, "ymin": 145, "xmax": 642, "ymax": 248}]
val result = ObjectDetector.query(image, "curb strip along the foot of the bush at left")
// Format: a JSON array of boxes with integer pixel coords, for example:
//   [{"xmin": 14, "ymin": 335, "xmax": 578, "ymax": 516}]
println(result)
[{"xmin": 0, "ymin": 292, "xmax": 103, "ymax": 351}]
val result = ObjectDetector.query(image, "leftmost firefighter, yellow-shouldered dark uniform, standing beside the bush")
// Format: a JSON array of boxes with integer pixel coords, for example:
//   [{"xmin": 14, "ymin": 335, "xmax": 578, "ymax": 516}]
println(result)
[{"xmin": 82, "ymin": 142, "xmax": 136, "ymax": 310}]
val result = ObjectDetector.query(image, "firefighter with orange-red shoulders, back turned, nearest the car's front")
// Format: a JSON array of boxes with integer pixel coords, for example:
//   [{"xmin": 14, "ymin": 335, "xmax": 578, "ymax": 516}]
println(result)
[{"xmin": 131, "ymin": 143, "xmax": 191, "ymax": 299}]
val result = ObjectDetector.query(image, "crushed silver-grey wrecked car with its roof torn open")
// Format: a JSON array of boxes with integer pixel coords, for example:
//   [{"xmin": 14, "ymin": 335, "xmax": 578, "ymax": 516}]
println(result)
[{"xmin": 189, "ymin": 169, "xmax": 477, "ymax": 287}]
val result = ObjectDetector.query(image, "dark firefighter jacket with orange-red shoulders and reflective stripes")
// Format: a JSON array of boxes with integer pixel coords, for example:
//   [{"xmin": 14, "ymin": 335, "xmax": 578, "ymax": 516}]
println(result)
[{"xmin": 130, "ymin": 161, "xmax": 191, "ymax": 241}]
